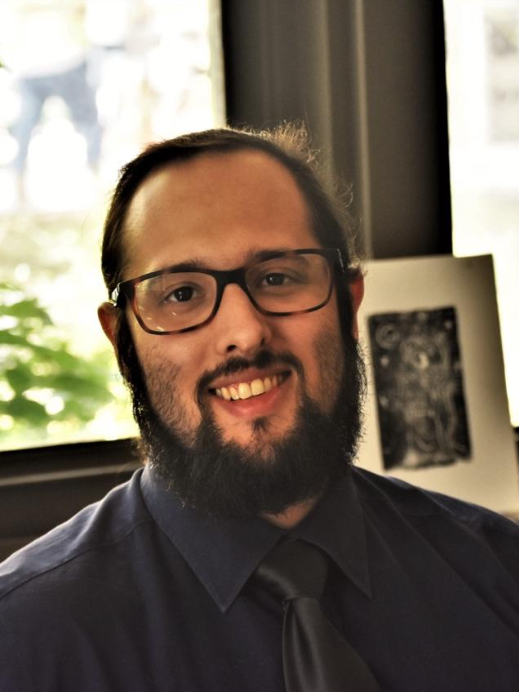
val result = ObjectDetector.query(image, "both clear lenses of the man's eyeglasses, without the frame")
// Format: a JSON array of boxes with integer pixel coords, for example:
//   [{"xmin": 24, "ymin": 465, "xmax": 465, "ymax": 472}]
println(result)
[{"xmin": 134, "ymin": 254, "xmax": 331, "ymax": 332}]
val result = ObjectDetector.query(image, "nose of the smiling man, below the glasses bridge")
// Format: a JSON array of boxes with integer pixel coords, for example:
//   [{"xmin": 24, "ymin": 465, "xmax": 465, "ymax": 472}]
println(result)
[{"xmin": 213, "ymin": 284, "xmax": 272, "ymax": 357}]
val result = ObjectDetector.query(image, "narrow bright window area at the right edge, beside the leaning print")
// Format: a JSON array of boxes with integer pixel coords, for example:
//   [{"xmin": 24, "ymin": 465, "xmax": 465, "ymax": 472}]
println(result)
[{"xmin": 444, "ymin": 0, "xmax": 519, "ymax": 426}]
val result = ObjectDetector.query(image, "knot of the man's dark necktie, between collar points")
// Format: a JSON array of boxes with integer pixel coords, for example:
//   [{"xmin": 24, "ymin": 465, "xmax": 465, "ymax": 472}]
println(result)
[{"xmin": 255, "ymin": 541, "xmax": 328, "ymax": 602}]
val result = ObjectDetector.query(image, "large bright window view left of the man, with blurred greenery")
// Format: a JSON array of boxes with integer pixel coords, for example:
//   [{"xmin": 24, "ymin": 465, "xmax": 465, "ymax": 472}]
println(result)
[{"xmin": 0, "ymin": 0, "xmax": 224, "ymax": 449}]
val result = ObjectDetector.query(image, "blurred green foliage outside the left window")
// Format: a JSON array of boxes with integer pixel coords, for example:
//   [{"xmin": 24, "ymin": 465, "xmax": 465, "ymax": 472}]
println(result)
[{"xmin": 0, "ymin": 283, "xmax": 113, "ymax": 437}]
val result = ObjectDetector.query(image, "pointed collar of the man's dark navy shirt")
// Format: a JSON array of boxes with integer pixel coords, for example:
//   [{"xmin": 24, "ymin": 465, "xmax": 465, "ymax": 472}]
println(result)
[{"xmin": 141, "ymin": 466, "xmax": 371, "ymax": 612}]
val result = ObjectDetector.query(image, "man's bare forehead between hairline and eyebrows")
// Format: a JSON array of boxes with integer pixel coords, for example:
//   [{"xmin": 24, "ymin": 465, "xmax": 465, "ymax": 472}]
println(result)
[{"xmin": 124, "ymin": 150, "xmax": 319, "ymax": 278}]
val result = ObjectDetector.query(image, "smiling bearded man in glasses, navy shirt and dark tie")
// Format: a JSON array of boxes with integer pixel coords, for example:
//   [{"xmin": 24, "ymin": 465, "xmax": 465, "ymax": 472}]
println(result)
[{"xmin": 0, "ymin": 128, "xmax": 519, "ymax": 692}]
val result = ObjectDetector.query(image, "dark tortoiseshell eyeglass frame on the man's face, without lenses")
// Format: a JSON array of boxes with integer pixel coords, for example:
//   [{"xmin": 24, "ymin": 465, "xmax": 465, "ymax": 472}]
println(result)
[{"xmin": 109, "ymin": 248, "xmax": 347, "ymax": 336}]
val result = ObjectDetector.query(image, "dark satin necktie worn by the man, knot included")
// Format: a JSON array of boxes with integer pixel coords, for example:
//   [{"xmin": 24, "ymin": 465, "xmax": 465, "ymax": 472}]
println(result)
[{"xmin": 255, "ymin": 541, "xmax": 380, "ymax": 692}]
